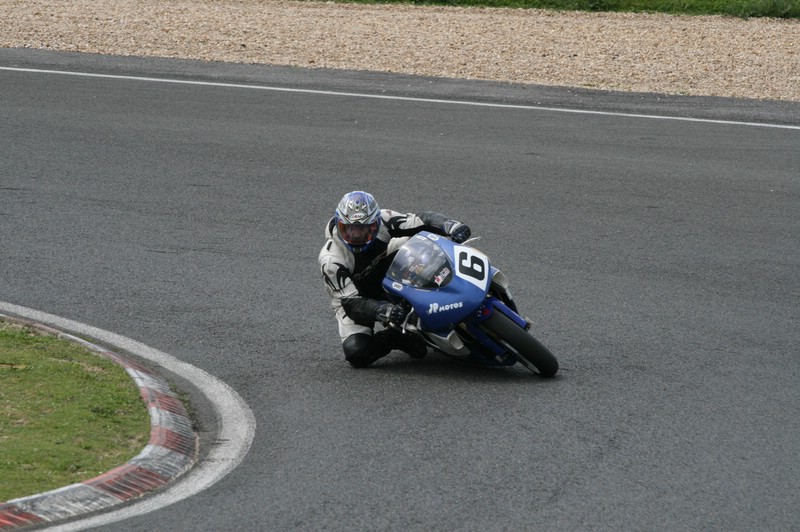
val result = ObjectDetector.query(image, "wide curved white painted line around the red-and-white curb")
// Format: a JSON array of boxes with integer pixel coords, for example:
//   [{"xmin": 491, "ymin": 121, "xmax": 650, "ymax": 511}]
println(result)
[{"xmin": 0, "ymin": 301, "xmax": 256, "ymax": 532}]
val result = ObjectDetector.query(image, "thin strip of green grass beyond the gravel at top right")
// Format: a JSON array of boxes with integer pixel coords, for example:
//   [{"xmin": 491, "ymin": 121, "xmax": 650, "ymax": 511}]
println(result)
[{"xmin": 332, "ymin": 0, "xmax": 800, "ymax": 18}]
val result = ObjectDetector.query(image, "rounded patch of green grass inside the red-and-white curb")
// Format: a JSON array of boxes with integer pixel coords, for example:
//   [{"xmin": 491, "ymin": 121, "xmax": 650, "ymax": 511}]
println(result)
[{"xmin": 0, "ymin": 321, "xmax": 150, "ymax": 501}]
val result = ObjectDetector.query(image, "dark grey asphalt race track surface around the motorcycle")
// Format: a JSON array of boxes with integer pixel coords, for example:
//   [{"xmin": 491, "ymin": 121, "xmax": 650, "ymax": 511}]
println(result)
[{"xmin": 0, "ymin": 50, "xmax": 800, "ymax": 530}]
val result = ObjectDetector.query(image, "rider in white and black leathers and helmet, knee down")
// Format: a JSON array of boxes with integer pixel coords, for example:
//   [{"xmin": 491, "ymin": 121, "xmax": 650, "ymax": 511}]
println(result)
[{"xmin": 319, "ymin": 190, "xmax": 471, "ymax": 368}]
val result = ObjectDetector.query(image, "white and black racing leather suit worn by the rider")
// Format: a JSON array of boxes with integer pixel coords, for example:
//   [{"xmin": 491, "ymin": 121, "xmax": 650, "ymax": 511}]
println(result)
[{"xmin": 319, "ymin": 209, "xmax": 452, "ymax": 341}]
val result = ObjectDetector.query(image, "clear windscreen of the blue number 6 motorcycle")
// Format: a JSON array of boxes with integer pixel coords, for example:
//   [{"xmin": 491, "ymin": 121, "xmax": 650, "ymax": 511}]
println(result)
[{"xmin": 386, "ymin": 237, "xmax": 453, "ymax": 289}]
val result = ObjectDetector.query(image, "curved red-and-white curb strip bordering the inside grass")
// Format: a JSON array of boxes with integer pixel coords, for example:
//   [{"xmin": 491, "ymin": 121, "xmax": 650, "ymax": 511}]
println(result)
[{"xmin": 0, "ymin": 314, "xmax": 197, "ymax": 530}]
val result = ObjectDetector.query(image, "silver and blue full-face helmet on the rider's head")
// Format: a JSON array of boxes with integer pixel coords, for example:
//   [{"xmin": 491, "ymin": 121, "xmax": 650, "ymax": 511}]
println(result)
[{"xmin": 336, "ymin": 190, "xmax": 381, "ymax": 253}]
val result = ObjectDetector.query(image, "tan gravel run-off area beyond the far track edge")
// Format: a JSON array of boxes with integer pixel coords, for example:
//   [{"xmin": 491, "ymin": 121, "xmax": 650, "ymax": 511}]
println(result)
[{"xmin": 0, "ymin": 0, "xmax": 800, "ymax": 101}]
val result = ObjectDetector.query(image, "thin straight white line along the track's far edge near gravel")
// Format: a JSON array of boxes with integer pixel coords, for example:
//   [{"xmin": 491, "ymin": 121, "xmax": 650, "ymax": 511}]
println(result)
[{"xmin": 0, "ymin": 66, "xmax": 800, "ymax": 130}]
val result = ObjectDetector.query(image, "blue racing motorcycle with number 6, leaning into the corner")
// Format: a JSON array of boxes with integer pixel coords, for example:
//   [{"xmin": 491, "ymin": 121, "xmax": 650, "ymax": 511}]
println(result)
[{"xmin": 383, "ymin": 231, "xmax": 558, "ymax": 377}]
